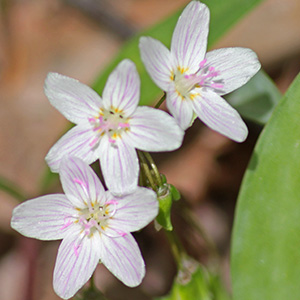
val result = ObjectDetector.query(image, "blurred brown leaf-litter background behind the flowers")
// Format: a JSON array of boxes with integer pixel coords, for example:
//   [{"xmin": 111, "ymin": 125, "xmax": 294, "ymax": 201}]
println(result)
[{"xmin": 0, "ymin": 0, "xmax": 300, "ymax": 300}]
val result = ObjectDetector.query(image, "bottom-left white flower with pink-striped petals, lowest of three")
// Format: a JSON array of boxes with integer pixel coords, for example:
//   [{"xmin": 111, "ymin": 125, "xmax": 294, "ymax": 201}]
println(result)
[{"xmin": 11, "ymin": 158, "xmax": 158, "ymax": 299}]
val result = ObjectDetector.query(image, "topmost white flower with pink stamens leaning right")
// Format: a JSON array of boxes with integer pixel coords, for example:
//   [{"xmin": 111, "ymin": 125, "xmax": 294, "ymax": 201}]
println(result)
[{"xmin": 140, "ymin": 1, "xmax": 260, "ymax": 142}]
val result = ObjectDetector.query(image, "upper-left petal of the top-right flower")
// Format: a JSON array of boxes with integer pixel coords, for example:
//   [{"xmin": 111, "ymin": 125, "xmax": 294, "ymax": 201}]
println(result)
[{"xmin": 139, "ymin": 37, "xmax": 173, "ymax": 91}]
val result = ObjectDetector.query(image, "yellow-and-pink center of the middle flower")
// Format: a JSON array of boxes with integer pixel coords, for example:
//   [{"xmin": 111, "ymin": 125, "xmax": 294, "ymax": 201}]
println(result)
[{"xmin": 89, "ymin": 107, "xmax": 130, "ymax": 147}]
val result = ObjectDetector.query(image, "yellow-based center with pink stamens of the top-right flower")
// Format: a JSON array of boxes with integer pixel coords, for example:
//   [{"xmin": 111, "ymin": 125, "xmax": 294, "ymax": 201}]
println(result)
[{"xmin": 172, "ymin": 59, "xmax": 224, "ymax": 100}]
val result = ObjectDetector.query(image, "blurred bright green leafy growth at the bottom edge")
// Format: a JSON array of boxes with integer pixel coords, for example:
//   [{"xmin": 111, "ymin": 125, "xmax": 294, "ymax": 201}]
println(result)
[{"xmin": 156, "ymin": 258, "xmax": 229, "ymax": 300}]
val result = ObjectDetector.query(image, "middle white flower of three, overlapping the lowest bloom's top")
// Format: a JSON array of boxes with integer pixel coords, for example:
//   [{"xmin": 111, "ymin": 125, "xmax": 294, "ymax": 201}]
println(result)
[{"xmin": 45, "ymin": 60, "xmax": 184, "ymax": 195}]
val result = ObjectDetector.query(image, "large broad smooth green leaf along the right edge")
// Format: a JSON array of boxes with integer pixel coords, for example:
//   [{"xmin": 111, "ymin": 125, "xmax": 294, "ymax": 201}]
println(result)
[{"xmin": 231, "ymin": 75, "xmax": 300, "ymax": 300}]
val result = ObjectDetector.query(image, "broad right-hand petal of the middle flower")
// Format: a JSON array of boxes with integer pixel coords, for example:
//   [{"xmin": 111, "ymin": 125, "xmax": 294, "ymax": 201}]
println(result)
[{"xmin": 126, "ymin": 106, "xmax": 184, "ymax": 151}]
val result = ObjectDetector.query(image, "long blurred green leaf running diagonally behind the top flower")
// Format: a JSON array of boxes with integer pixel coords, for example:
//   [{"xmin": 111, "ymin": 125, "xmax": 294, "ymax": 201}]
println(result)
[{"xmin": 93, "ymin": 0, "xmax": 261, "ymax": 105}]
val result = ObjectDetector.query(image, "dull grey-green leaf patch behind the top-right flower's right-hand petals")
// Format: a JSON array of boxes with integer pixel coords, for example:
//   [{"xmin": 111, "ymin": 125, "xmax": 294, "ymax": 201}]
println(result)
[{"xmin": 226, "ymin": 70, "xmax": 282, "ymax": 124}]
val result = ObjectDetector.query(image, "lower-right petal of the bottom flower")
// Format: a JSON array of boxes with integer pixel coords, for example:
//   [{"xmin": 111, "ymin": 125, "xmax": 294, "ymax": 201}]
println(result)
[{"xmin": 101, "ymin": 233, "xmax": 145, "ymax": 287}]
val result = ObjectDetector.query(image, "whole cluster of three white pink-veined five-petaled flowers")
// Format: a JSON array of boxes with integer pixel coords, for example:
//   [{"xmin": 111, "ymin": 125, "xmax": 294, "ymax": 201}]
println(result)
[{"xmin": 11, "ymin": 1, "xmax": 260, "ymax": 299}]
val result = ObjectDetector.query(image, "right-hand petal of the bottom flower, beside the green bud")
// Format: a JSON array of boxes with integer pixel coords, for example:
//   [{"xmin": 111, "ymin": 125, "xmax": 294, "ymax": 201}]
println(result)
[{"xmin": 105, "ymin": 187, "xmax": 158, "ymax": 234}]
